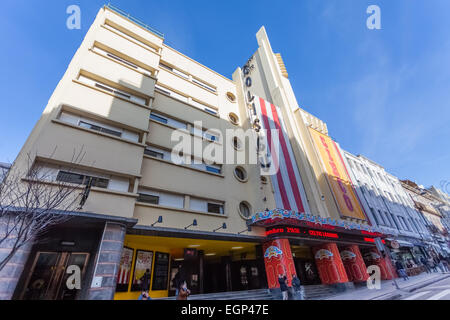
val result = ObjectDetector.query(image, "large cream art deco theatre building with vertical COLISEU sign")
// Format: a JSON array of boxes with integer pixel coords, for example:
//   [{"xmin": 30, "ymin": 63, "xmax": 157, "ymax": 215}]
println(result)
[{"xmin": 0, "ymin": 5, "xmax": 400, "ymax": 299}]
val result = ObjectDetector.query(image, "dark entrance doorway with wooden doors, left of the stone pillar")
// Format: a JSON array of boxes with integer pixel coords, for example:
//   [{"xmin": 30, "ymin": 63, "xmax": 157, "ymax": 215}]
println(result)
[{"xmin": 21, "ymin": 251, "xmax": 89, "ymax": 300}]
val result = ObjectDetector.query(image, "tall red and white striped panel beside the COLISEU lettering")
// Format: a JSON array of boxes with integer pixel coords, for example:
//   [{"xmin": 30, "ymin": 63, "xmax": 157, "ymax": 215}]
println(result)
[{"xmin": 253, "ymin": 96, "xmax": 309, "ymax": 213}]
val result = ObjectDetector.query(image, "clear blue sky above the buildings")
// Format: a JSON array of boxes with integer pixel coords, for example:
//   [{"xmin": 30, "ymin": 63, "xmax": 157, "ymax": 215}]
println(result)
[{"xmin": 0, "ymin": 0, "xmax": 450, "ymax": 190}]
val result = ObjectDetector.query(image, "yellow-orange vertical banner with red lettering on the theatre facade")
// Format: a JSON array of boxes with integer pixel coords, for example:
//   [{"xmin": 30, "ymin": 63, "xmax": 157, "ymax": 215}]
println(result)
[{"xmin": 309, "ymin": 127, "xmax": 366, "ymax": 220}]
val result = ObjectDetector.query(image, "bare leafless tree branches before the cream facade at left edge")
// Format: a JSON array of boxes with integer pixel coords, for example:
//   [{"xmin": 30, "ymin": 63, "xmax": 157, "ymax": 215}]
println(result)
[{"xmin": 0, "ymin": 147, "xmax": 86, "ymax": 271}]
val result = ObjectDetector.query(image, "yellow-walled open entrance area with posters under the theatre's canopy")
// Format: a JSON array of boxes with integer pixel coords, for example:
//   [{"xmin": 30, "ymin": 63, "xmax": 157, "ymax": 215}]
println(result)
[{"xmin": 114, "ymin": 235, "xmax": 265, "ymax": 300}]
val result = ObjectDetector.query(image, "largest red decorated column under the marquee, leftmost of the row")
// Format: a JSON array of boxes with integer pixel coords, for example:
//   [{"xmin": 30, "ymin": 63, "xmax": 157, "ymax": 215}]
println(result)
[{"xmin": 263, "ymin": 239, "xmax": 296, "ymax": 289}]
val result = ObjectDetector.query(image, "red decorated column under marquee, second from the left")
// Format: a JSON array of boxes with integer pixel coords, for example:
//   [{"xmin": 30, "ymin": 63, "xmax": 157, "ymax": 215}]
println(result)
[{"xmin": 313, "ymin": 243, "xmax": 348, "ymax": 284}]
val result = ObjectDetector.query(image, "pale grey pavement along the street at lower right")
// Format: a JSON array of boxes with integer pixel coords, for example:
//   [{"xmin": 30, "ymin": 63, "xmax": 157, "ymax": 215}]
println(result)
[{"xmin": 325, "ymin": 272, "xmax": 450, "ymax": 300}]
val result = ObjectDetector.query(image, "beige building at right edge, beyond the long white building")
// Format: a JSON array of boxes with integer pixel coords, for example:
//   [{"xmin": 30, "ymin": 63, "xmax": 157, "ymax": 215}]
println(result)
[{"xmin": 401, "ymin": 180, "xmax": 449, "ymax": 255}]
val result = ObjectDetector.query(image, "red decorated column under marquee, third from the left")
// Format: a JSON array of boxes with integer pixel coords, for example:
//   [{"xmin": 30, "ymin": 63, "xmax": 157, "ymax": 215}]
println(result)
[{"xmin": 341, "ymin": 245, "xmax": 369, "ymax": 282}]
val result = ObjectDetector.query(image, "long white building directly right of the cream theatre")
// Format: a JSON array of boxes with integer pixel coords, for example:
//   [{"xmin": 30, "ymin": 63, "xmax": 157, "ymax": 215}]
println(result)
[{"xmin": 345, "ymin": 152, "xmax": 433, "ymax": 274}]
